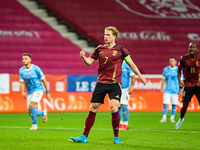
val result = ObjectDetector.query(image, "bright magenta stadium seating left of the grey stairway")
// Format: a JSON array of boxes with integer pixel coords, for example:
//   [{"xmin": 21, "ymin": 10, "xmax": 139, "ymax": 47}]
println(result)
[{"xmin": 0, "ymin": 0, "xmax": 98, "ymax": 74}]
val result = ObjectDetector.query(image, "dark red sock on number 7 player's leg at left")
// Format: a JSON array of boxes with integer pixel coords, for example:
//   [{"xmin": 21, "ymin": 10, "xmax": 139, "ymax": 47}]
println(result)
[{"xmin": 83, "ymin": 111, "xmax": 96, "ymax": 137}]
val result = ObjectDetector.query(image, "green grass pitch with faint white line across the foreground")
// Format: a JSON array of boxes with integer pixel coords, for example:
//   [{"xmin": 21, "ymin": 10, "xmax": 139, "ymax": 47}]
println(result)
[{"xmin": 0, "ymin": 112, "xmax": 200, "ymax": 150}]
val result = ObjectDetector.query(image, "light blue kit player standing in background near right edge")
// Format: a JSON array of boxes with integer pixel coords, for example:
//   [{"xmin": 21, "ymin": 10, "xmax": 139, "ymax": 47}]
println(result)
[{"xmin": 160, "ymin": 57, "xmax": 182, "ymax": 123}]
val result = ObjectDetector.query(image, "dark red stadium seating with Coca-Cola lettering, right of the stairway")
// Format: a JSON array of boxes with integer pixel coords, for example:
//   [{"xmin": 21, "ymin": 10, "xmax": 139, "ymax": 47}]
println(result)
[{"xmin": 37, "ymin": 0, "xmax": 200, "ymax": 74}]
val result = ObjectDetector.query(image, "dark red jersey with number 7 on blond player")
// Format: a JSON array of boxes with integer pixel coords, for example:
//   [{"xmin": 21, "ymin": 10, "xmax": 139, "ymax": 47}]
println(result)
[{"xmin": 90, "ymin": 44, "xmax": 129, "ymax": 84}]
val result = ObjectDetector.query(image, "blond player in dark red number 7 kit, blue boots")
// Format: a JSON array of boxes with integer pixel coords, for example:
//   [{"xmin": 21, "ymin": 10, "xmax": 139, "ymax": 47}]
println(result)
[{"xmin": 70, "ymin": 26, "xmax": 146, "ymax": 144}]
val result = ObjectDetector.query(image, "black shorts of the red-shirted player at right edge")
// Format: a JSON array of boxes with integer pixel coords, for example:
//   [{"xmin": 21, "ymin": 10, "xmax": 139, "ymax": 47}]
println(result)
[{"xmin": 182, "ymin": 86, "xmax": 200, "ymax": 102}]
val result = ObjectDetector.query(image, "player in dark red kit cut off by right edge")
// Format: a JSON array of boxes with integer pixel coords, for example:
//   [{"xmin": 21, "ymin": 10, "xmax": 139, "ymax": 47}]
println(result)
[{"xmin": 175, "ymin": 43, "xmax": 200, "ymax": 129}]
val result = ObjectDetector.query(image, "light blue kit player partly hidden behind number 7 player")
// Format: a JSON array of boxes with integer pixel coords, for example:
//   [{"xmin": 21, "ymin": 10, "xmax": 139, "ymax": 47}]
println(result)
[{"xmin": 118, "ymin": 61, "xmax": 135, "ymax": 130}]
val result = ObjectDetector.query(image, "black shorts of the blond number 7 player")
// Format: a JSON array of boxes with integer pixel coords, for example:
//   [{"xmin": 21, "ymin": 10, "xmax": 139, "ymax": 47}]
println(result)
[{"xmin": 90, "ymin": 82, "xmax": 121, "ymax": 104}]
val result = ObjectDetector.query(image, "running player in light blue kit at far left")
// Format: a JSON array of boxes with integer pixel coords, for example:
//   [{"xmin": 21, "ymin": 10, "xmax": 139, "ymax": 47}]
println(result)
[{"xmin": 19, "ymin": 53, "xmax": 51, "ymax": 130}]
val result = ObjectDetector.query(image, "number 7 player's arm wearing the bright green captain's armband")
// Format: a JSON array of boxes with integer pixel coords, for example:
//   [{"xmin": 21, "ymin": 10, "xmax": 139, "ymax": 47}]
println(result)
[{"xmin": 124, "ymin": 55, "xmax": 147, "ymax": 85}]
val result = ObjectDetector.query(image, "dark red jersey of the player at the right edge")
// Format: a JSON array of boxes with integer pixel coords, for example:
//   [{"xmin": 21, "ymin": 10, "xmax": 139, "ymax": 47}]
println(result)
[{"xmin": 179, "ymin": 54, "xmax": 200, "ymax": 87}]
